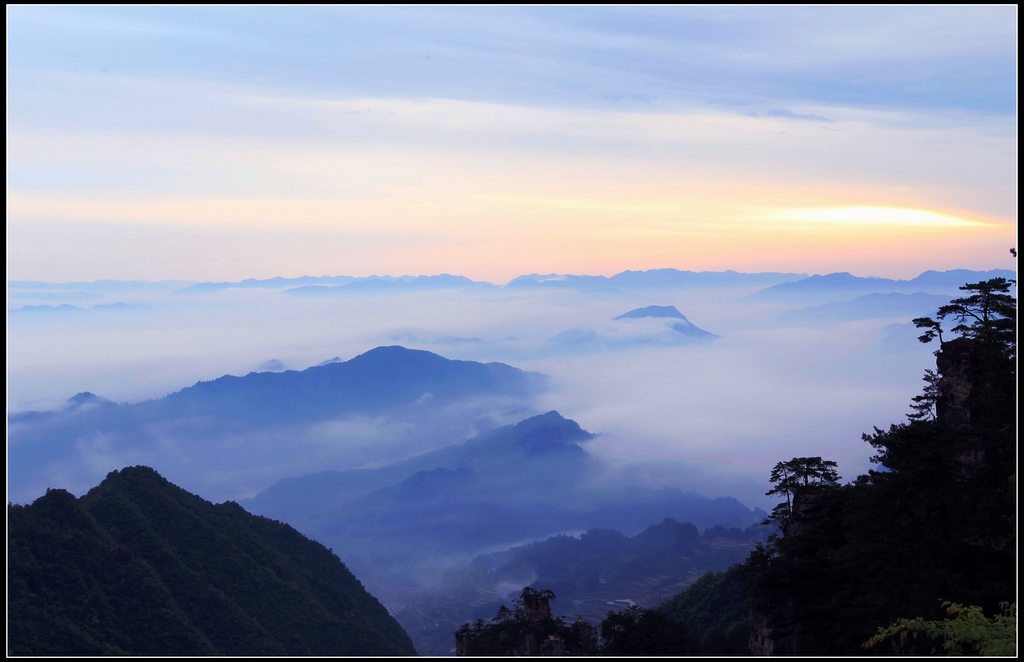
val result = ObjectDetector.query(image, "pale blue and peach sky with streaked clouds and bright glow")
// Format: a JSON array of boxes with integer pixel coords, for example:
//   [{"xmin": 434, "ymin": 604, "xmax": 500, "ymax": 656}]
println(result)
[{"xmin": 7, "ymin": 5, "xmax": 1017, "ymax": 283}]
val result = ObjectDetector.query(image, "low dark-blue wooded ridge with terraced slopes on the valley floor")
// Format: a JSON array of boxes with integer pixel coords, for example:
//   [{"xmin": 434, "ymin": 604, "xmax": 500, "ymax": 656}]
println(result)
[{"xmin": 403, "ymin": 519, "xmax": 767, "ymax": 655}]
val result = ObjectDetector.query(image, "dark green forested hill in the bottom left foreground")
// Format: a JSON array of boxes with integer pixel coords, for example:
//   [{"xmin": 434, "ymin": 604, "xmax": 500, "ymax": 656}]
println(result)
[{"xmin": 7, "ymin": 466, "xmax": 416, "ymax": 656}]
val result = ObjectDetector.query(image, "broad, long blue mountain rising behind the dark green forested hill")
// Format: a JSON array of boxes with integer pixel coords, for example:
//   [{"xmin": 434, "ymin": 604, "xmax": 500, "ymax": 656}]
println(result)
[{"xmin": 8, "ymin": 346, "xmax": 546, "ymax": 501}]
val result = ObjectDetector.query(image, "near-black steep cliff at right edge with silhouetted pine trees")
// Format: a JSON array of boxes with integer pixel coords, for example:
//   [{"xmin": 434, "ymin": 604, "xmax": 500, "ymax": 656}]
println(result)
[{"xmin": 745, "ymin": 279, "xmax": 1017, "ymax": 655}]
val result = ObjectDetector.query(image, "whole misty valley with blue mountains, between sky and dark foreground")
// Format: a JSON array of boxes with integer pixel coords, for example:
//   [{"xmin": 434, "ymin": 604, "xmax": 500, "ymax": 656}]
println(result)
[{"xmin": 8, "ymin": 270, "xmax": 1012, "ymax": 655}]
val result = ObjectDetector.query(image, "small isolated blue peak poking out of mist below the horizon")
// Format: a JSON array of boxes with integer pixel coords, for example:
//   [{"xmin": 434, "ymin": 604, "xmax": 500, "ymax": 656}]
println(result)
[{"xmin": 548, "ymin": 305, "xmax": 718, "ymax": 351}]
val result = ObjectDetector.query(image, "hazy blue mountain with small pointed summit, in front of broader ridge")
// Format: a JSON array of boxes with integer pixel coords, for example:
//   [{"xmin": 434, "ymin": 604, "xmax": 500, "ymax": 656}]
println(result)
[{"xmin": 243, "ymin": 411, "xmax": 758, "ymax": 595}]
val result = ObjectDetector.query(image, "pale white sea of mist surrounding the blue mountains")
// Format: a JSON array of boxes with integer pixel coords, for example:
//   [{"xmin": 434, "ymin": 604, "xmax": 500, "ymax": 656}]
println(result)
[{"xmin": 8, "ymin": 276, "xmax": 933, "ymax": 514}]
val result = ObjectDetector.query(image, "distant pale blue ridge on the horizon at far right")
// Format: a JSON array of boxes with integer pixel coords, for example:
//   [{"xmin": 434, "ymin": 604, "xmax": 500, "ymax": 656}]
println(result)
[{"xmin": 749, "ymin": 268, "xmax": 1017, "ymax": 304}]
